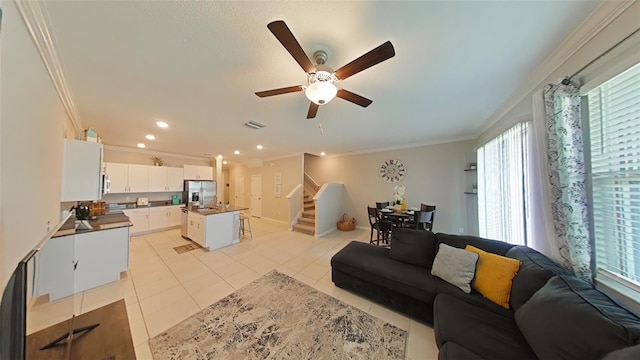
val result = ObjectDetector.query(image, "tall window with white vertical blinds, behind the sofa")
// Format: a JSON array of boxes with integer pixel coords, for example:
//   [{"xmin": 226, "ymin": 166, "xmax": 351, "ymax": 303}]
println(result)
[{"xmin": 477, "ymin": 123, "xmax": 528, "ymax": 245}]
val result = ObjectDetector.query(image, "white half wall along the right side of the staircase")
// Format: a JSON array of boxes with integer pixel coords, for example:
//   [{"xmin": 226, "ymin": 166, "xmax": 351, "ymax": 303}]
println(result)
[{"xmin": 313, "ymin": 183, "xmax": 346, "ymax": 237}]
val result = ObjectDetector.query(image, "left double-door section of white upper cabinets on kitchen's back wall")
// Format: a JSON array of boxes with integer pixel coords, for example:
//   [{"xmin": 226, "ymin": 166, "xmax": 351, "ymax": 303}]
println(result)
[{"xmin": 105, "ymin": 163, "xmax": 149, "ymax": 193}]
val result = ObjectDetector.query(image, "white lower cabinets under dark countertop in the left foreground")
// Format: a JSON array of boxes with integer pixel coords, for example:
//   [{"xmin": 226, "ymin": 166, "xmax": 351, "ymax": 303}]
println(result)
[{"xmin": 34, "ymin": 227, "xmax": 129, "ymax": 301}]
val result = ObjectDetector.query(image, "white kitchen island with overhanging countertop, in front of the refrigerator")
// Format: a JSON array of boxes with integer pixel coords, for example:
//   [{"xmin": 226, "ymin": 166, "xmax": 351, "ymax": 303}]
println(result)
[{"xmin": 187, "ymin": 206, "xmax": 249, "ymax": 250}]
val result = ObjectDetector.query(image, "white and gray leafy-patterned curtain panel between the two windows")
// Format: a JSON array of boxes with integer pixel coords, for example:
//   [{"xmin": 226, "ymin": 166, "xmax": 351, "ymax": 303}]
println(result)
[{"xmin": 543, "ymin": 80, "xmax": 591, "ymax": 280}]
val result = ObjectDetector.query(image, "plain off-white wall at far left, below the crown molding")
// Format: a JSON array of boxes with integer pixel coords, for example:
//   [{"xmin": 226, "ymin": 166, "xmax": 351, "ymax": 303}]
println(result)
[{"xmin": 0, "ymin": 1, "xmax": 68, "ymax": 288}]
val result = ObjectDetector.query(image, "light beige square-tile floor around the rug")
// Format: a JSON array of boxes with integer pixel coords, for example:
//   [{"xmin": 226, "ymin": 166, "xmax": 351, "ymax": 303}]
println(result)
[{"xmin": 29, "ymin": 218, "xmax": 438, "ymax": 360}]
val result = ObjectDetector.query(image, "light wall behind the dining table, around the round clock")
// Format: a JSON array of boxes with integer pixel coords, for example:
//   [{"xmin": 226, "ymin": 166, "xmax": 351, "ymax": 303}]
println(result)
[{"xmin": 305, "ymin": 141, "xmax": 477, "ymax": 234}]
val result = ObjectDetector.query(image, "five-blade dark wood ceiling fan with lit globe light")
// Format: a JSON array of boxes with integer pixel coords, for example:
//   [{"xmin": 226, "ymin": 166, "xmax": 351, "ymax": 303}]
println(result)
[{"xmin": 256, "ymin": 20, "xmax": 396, "ymax": 119}]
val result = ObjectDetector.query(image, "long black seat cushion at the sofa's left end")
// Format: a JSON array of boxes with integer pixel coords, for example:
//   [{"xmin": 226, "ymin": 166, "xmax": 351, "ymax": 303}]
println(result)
[{"xmin": 331, "ymin": 241, "xmax": 436, "ymax": 304}]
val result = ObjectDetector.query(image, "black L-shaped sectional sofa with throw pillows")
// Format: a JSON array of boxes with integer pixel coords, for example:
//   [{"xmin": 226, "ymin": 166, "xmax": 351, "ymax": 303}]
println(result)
[{"xmin": 331, "ymin": 229, "xmax": 640, "ymax": 360}]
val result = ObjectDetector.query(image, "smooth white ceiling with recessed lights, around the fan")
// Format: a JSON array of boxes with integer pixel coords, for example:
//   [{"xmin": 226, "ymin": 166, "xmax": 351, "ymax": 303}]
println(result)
[{"xmin": 46, "ymin": 0, "xmax": 599, "ymax": 163}]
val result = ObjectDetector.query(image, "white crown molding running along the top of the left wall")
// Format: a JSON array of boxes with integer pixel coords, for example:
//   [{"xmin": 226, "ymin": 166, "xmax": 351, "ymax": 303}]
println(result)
[{"xmin": 14, "ymin": 0, "xmax": 84, "ymax": 134}]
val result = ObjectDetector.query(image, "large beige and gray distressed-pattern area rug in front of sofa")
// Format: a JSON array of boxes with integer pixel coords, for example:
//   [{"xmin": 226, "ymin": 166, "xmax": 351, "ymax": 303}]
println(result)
[{"xmin": 149, "ymin": 270, "xmax": 407, "ymax": 360}]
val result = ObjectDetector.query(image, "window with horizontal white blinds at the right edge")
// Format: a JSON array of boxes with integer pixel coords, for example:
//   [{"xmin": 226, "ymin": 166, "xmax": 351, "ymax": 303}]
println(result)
[{"xmin": 586, "ymin": 64, "xmax": 640, "ymax": 291}]
